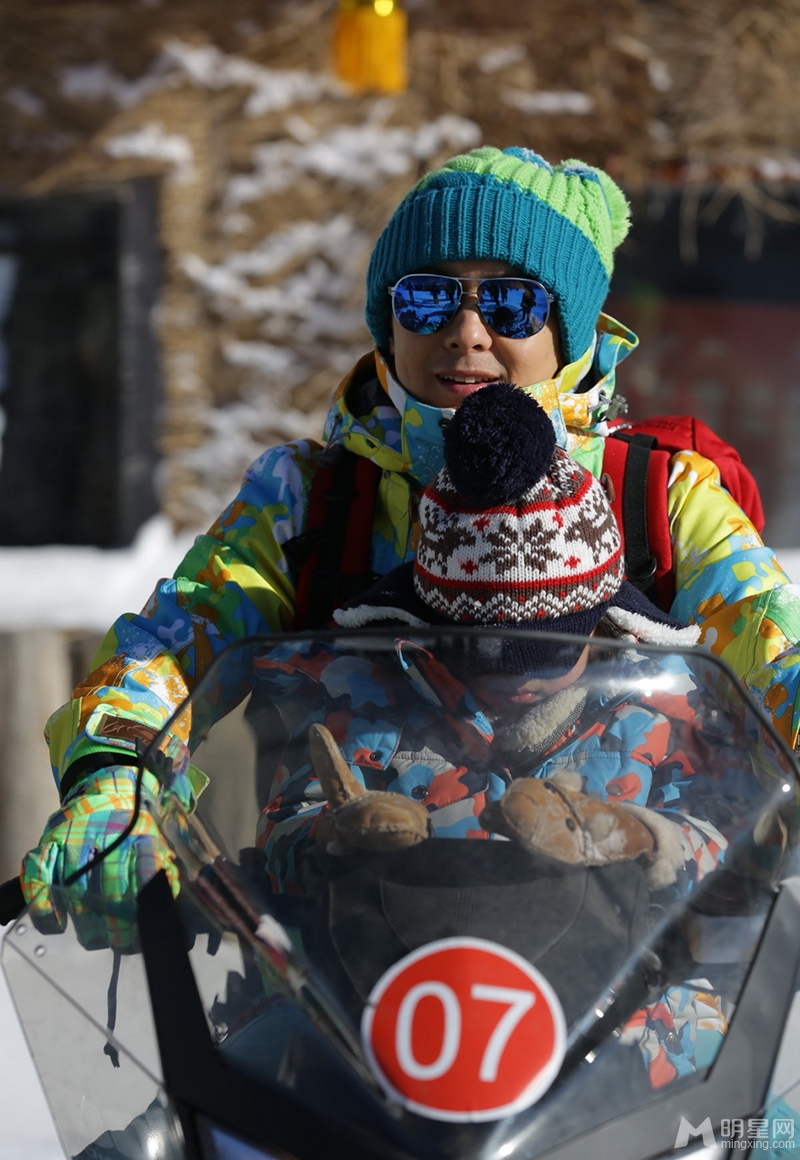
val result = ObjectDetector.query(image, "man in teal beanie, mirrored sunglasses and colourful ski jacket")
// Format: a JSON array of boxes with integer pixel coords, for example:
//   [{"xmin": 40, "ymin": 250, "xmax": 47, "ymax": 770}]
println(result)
[{"xmin": 22, "ymin": 147, "xmax": 800, "ymax": 923}]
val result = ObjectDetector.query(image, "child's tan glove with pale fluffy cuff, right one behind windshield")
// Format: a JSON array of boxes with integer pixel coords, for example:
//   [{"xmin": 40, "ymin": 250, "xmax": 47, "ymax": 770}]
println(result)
[{"xmin": 479, "ymin": 775, "xmax": 685, "ymax": 887}]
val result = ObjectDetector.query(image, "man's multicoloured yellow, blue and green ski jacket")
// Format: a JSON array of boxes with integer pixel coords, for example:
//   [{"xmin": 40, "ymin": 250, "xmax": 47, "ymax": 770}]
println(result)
[{"xmin": 46, "ymin": 316, "xmax": 800, "ymax": 784}]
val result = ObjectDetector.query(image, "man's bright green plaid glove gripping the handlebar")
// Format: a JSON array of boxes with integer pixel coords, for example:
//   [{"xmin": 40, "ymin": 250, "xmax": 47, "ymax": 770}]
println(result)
[{"xmin": 20, "ymin": 766, "xmax": 179, "ymax": 950}]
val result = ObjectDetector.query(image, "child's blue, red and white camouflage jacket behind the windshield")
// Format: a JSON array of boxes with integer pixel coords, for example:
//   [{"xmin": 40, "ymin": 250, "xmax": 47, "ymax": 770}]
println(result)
[{"xmin": 252, "ymin": 630, "xmax": 737, "ymax": 893}]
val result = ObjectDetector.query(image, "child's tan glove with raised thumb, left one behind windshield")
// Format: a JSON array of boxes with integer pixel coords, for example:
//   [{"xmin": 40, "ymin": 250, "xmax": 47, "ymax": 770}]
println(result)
[{"xmin": 308, "ymin": 725, "xmax": 430, "ymax": 854}]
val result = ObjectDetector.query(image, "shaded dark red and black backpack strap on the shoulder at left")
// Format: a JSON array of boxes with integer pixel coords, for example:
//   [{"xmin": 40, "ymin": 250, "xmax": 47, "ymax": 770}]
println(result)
[{"xmin": 284, "ymin": 447, "xmax": 380, "ymax": 629}]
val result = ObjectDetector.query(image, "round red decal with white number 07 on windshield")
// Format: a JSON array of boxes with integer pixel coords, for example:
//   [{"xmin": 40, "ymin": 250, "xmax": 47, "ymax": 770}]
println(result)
[{"xmin": 362, "ymin": 938, "xmax": 567, "ymax": 1121}]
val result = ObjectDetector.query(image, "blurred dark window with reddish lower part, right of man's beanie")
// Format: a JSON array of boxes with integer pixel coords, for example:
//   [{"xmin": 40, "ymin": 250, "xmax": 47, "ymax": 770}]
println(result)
[{"xmin": 606, "ymin": 187, "xmax": 800, "ymax": 548}]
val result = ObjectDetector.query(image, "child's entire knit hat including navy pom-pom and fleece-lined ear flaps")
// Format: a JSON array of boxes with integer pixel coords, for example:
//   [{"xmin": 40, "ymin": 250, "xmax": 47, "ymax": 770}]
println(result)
[{"xmin": 334, "ymin": 383, "xmax": 698, "ymax": 672}]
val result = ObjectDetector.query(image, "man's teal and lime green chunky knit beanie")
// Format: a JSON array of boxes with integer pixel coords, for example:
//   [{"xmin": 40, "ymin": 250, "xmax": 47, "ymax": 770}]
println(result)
[{"xmin": 366, "ymin": 146, "xmax": 630, "ymax": 363}]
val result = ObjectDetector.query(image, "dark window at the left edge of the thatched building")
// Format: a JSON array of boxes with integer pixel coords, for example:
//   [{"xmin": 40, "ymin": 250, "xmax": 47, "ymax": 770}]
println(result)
[{"xmin": 0, "ymin": 180, "xmax": 159, "ymax": 548}]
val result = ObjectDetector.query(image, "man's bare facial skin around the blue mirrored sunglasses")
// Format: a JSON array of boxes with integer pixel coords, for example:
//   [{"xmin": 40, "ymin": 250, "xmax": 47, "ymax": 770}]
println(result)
[{"xmin": 390, "ymin": 261, "xmax": 561, "ymax": 407}]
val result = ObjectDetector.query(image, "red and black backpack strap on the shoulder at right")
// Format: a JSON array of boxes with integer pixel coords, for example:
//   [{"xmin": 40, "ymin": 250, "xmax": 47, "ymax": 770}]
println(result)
[{"xmin": 603, "ymin": 432, "xmax": 675, "ymax": 611}]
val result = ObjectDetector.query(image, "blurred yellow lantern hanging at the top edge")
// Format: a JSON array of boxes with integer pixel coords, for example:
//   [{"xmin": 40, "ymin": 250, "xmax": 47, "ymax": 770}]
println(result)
[{"xmin": 333, "ymin": 0, "xmax": 408, "ymax": 93}]
